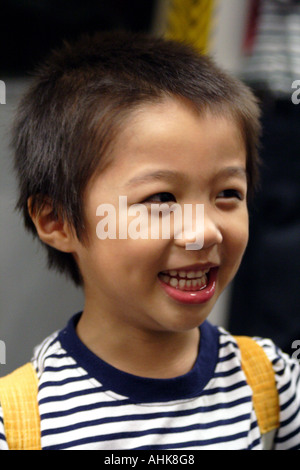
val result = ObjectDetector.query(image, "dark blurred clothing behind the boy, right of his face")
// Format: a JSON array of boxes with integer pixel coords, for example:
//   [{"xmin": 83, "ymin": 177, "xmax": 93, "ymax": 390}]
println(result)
[{"xmin": 228, "ymin": 100, "xmax": 300, "ymax": 354}]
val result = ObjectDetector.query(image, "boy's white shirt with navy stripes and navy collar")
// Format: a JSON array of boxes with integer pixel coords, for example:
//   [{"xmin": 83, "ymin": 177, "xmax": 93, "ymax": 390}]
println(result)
[{"xmin": 0, "ymin": 314, "xmax": 300, "ymax": 451}]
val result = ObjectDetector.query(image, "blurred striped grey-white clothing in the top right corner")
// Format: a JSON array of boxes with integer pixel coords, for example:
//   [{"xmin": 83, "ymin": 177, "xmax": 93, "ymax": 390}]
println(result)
[{"xmin": 241, "ymin": 0, "xmax": 300, "ymax": 99}]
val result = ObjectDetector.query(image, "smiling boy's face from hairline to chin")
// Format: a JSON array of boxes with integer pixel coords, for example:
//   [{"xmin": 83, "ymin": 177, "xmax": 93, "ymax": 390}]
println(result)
[{"xmin": 75, "ymin": 99, "xmax": 248, "ymax": 332}]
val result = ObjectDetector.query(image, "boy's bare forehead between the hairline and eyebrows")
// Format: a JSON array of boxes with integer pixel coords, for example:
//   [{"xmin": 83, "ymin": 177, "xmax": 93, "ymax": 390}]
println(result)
[{"xmin": 111, "ymin": 98, "xmax": 246, "ymax": 171}]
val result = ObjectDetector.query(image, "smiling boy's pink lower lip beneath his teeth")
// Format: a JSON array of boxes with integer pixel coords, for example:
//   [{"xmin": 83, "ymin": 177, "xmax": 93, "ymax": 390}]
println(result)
[{"xmin": 158, "ymin": 268, "xmax": 218, "ymax": 305}]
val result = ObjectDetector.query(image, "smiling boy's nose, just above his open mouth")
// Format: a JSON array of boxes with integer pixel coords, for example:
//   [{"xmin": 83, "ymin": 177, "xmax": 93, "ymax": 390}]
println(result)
[{"xmin": 174, "ymin": 204, "xmax": 223, "ymax": 250}]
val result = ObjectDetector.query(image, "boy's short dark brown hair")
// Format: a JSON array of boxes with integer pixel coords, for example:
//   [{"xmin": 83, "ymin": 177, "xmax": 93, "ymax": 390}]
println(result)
[{"xmin": 12, "ymin": 32, "xmax": 260, "ymax": 285}]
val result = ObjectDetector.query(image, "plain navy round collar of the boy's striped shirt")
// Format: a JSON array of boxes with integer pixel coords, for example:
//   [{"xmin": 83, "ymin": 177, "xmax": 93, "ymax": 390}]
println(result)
[{"xmin": 58, "ymin": 313, "xmax": 219, "ymax": 403}]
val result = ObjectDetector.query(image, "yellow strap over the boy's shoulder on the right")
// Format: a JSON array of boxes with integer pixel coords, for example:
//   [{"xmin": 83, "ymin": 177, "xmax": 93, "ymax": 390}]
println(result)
[{"xmin": 234, "ymin": 336, "xmax": 279, "ymax": 434}]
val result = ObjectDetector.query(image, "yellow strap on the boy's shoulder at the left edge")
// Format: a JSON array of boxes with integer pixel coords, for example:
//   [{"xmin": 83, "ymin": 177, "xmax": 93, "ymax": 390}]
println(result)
[{"xmin": 0, "ymin": 363, "xmax": 41, "ymax": 450}]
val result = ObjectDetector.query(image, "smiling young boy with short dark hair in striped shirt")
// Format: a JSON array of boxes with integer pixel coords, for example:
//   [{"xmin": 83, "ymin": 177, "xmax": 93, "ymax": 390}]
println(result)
[{"xmin": 0, "ymin": 33, "xmax": 300, "ymax": 451}]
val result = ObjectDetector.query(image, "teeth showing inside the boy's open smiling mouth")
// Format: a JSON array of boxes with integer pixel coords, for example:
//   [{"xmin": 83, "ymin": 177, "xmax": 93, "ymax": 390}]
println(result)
[{"xmin": 158, "ymin": 269, "xmax": 209, "ymax": 292}]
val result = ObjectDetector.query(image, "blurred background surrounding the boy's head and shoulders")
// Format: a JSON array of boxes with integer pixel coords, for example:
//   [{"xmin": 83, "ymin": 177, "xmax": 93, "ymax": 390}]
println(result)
[{"xmin": 0, "ymin": 0, "xmax": 300, "ymax": 376}]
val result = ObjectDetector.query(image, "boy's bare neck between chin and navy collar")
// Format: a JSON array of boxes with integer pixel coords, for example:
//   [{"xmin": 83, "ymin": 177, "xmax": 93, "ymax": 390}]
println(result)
[{"xmin": 77, "ymin": 310, "xmax": 200, "ymax": 378}]
